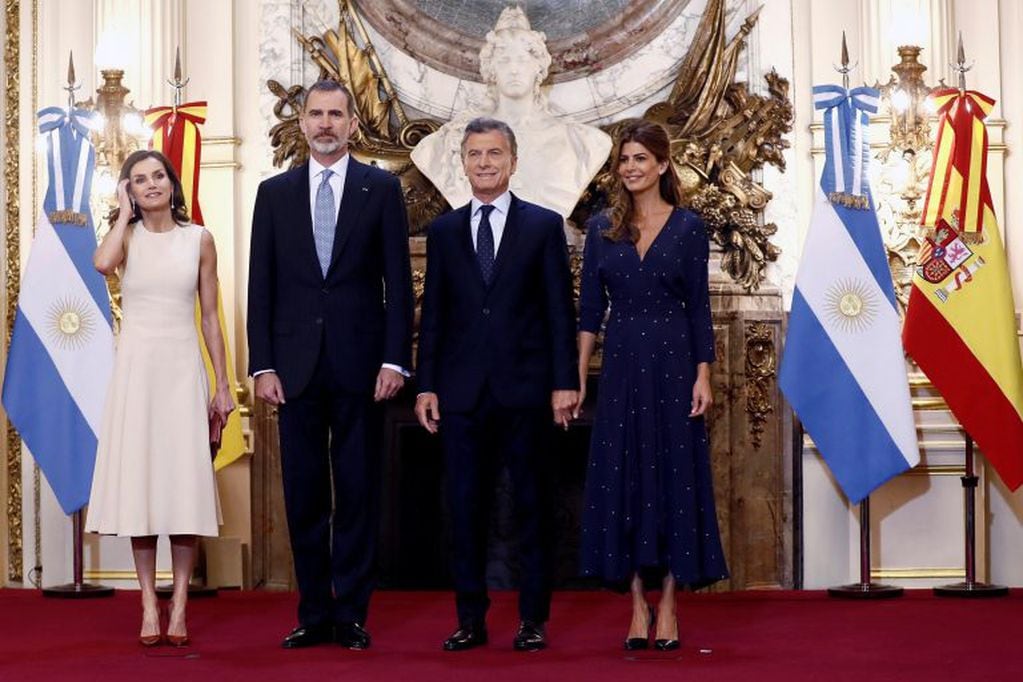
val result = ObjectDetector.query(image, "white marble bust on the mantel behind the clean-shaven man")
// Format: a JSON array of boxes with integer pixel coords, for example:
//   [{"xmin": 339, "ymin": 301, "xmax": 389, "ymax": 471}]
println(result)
[{"xmin": 412, "ymin": 7, "xmax": 612, "ymax": 218}]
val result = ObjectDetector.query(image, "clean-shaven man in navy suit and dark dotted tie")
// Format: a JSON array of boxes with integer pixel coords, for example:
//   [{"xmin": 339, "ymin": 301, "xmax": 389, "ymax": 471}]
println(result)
[{"xmin": 415, "ymin": 119, "xmax": 579, "ymax": 650}]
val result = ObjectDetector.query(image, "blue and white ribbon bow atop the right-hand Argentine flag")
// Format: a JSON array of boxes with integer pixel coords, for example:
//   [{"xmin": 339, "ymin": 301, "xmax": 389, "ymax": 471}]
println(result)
[{"xmin": 813, "ymin": 85, "xmax": 881, "ymax": 209}]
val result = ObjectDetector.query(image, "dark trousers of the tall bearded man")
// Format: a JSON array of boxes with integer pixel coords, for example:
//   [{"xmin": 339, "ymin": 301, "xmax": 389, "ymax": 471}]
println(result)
[{"xmin": 279, "ymin": 353, "xmax": 384, "ymax": 626}]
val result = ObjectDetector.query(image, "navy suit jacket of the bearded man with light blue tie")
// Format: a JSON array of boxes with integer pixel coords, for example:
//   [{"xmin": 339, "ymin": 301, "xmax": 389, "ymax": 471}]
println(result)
[{"xmin": 248, "ymin": 157, "xmax": 413, "ymax": 397}]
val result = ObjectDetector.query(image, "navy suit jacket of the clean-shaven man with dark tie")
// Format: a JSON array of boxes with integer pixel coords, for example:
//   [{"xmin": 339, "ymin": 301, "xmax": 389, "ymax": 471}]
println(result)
[{"xmin": 416, "ymin": 195, "xmax": 579, "ymax": 414}]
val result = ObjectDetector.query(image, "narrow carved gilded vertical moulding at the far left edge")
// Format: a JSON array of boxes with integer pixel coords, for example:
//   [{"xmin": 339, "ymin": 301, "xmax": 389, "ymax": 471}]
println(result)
[{"xmin": 3, "ymin": 0, "xmax": 25, "ymax": 583}]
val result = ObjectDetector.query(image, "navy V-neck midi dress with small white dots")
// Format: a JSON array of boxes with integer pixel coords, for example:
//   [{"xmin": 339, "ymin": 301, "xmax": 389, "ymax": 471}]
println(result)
[{"xmin": 579, "ymin": 209, "xmax": 728, "ymax": 588}]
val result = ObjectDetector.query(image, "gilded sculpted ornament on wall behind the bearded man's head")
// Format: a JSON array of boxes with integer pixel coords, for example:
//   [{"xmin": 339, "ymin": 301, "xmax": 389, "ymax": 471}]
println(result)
[{"xmin": 267, "ymin": 0, "xmax": 447, "ymax": 235}]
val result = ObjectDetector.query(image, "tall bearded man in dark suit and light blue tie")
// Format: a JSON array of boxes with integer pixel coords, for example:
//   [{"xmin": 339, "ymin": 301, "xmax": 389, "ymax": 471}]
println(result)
[{"xmin": 249, "ymin": 81, "xmax": 413, "ymax": 649}]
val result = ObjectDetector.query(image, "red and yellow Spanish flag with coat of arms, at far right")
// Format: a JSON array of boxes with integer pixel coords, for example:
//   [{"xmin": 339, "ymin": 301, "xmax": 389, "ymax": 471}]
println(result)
[{"xmin": 902, "ymin": 89, "xmax": 1023, "ymax": 490}]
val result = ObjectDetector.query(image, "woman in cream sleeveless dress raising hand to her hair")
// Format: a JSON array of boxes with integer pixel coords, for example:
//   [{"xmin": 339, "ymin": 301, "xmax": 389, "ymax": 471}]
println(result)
[{"xmin": 86, "ymin": 151, "xmax": 234, "ymax": 646}]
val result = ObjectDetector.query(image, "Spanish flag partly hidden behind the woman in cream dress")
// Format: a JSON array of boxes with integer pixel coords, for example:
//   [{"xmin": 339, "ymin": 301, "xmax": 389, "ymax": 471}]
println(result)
[{"xmin": 144, "ymin": 102, "xmax": 246, "ymax": 471}]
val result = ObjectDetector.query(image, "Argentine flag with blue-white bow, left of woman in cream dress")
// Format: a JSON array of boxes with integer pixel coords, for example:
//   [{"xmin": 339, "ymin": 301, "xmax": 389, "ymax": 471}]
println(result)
[{"xmin": 3, "ymin": 106, "xmax": 114, "ymax": 514}]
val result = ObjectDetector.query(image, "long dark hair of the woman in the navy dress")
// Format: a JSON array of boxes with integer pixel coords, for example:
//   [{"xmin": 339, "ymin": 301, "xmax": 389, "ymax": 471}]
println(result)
[{"xmin": 605, "ymin": 120, "xmax": 681, "ymax": 243}]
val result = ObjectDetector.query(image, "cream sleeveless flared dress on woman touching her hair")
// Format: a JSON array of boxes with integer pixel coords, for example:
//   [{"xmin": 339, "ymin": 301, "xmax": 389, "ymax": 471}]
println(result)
[{"xmin": 86, "ymin": 222, "xmax": 221, "ymax": 536}]
